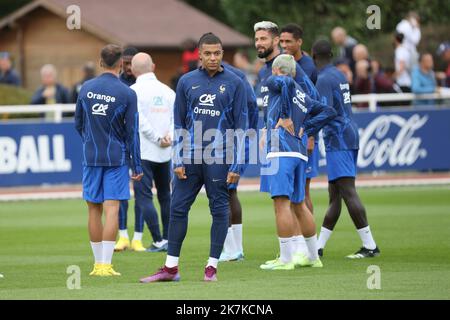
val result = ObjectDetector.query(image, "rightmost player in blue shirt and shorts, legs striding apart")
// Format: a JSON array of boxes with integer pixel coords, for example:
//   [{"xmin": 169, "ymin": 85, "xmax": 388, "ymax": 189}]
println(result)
[{"xmin": 313, "ymin": 40, "xmax": 380, "ymax": 259}]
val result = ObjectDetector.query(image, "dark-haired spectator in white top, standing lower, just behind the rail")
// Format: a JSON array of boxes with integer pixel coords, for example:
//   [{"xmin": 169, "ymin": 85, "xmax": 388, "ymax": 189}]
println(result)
[{"xmin": 394, "ymin": 33, "xmax": 411, "ymax": 92}]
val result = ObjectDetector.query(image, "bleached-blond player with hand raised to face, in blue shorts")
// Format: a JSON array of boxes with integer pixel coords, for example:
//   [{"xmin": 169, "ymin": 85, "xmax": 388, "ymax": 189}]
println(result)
[{"xmin": 260, "ymin": 54, "xmax": 336, "ymax": 270}]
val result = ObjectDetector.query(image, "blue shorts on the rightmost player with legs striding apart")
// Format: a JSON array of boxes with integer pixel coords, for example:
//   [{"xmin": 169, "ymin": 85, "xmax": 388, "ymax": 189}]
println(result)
[{"xmin": 327, "ymin": 150, "xmax": 358, "ymax": 181}]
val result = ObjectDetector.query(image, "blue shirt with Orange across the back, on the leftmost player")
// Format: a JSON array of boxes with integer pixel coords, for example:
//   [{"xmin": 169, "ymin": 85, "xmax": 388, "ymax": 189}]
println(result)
[{"xmin": 75, "ymin": 73, "xmax": 142, "ymax": 174}]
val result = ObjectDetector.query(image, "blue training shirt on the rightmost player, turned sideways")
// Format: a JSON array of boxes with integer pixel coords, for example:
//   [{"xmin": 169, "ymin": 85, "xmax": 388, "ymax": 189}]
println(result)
[{"xmin": 316, "ymin": 64, "xmax": 359, "ymax": 151}]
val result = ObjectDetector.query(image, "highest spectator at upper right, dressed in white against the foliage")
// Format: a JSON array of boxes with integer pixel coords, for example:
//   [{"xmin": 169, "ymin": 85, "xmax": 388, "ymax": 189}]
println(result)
[{"xmin": 396, "ymin": 11, "xmax": 422, "ymax": 67}]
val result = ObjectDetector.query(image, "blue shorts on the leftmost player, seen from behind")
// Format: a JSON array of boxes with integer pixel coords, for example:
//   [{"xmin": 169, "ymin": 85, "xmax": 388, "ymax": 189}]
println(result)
[{"xmin": 83, "ymin": 166, "xmax": 130, "ymax": 203}]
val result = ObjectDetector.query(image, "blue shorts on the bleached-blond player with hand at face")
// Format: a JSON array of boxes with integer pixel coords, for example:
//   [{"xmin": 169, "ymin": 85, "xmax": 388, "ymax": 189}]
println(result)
[{"xmin": 267, "ymin": 157, "xmax": 306, "ymax": 203}]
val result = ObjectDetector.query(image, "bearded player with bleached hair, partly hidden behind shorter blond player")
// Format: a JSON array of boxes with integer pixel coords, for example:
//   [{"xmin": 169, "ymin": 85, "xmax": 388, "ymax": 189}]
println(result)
[{"xmin": 254, "ymin": 21, "xmax": 320, "ymax": 262}]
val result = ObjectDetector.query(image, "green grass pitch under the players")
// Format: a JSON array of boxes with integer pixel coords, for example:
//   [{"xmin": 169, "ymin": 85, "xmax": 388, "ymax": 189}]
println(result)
[{"xmin": 0, "ymin": 186, "xmax": 450, "ymax": 300}]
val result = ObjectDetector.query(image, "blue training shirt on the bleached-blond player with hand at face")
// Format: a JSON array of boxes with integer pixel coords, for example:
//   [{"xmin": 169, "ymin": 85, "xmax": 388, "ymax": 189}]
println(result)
[{"xmin": 267, "ymin": 76, "xmax": 336, "ymax": 161}]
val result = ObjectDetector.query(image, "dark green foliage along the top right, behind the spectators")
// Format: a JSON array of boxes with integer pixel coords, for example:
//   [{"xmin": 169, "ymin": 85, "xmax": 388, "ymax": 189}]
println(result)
[{"xmin": 186, "ymin": 0, "xmax": 450, "ymax": 56}]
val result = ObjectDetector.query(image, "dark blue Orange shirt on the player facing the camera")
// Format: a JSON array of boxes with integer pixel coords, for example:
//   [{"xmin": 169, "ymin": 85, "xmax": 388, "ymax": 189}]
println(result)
[{"xmin": 173, "ymin": 66, "xmax": 248, "ymax": 173}]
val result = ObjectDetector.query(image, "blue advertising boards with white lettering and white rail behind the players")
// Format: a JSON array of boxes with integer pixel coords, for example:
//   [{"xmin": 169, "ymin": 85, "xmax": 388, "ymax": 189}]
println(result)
[{"xmin": 0, "ymin": 93, "xmax": 450, "ymax": 187}]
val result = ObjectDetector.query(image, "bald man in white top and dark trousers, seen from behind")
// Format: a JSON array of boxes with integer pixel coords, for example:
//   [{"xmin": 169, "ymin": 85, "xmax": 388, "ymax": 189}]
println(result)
[{"xmin": 131, "ymin": 52, "xmax": 175, "ymax": 252}]
